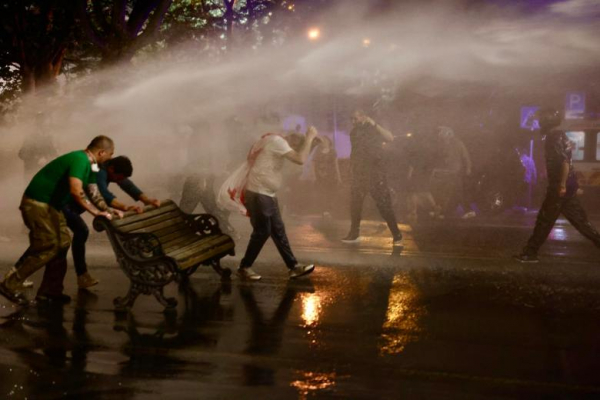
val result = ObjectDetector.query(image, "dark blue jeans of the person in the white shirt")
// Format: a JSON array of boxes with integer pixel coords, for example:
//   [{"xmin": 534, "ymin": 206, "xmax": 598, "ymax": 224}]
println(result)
[{"xmin": 240, "ymin": 191, "xmax": 298, "ymax": 269}]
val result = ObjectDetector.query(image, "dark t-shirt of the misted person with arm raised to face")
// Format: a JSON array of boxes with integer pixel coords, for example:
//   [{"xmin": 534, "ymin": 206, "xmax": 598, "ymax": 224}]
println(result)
[{"xmin": 350, "ymin": 123, "xmax": 385, "ymax": 168}]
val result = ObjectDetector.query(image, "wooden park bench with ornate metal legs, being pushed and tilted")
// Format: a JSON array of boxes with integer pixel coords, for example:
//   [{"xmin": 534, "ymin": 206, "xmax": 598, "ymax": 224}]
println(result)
[{"xmin": 94, "ymin": 200, "xmax": 235, "ymax": 310}]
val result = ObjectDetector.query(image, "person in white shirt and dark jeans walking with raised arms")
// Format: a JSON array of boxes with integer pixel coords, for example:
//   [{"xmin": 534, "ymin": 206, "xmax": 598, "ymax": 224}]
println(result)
[{"xmin": 237, "ymin": 127, "xmax": 317, "ymax": 281}]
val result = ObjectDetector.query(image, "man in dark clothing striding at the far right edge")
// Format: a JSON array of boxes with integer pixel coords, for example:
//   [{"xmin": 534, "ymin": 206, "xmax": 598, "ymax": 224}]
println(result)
[{"xmin": 515, "ymin": 109, "xmax": 600, "ymax": 263}]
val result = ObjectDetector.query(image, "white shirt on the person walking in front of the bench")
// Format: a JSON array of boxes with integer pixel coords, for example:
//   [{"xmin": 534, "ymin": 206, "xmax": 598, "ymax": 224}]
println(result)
[{"xmin": 246, "ymin": 136, "xmax": 293, "ymax": 197}]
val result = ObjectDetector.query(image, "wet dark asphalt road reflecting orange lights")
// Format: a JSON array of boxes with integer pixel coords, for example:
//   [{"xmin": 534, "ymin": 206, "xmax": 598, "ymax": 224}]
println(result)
[{"xmin": 0, "ymin": 216, "xmax": 600, "ymax": 400}]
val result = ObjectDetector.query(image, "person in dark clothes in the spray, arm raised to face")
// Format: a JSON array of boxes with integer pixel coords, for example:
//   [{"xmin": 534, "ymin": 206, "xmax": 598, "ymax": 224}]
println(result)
[{"xmin": 342, "ymin": 110, "xmax": 402, "ymax": 245}]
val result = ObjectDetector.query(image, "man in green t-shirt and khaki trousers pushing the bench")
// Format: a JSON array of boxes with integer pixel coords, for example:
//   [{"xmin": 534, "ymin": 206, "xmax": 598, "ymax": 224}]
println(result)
[{"xmin": 0, "ymin": 136, "xmax": 122, "ymax": 304}]
